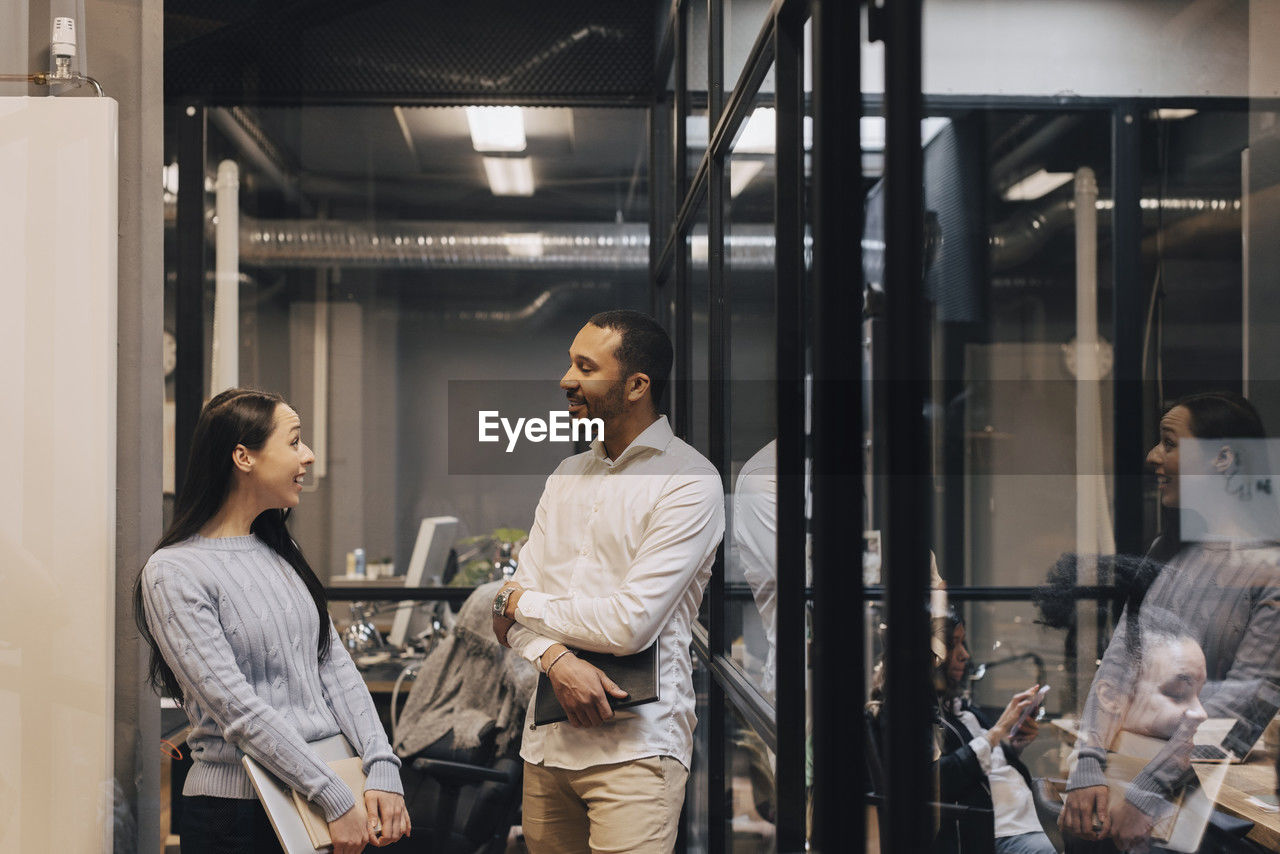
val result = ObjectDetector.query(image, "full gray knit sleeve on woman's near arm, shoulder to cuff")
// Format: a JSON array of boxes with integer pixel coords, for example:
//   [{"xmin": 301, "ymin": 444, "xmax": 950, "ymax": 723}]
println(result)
[{"xmin": 142, "ymin": 561, "xmax": 356, "ymax": 821}]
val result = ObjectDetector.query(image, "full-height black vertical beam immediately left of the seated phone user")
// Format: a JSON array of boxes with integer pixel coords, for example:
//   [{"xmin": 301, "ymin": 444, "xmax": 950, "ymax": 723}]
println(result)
[{"xmin": 883, "ymin": 0, "xmax": 933, "ymax": 851}]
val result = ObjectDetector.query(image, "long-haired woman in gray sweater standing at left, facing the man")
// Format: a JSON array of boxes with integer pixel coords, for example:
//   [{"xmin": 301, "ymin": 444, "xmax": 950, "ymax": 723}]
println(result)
[{"xmin": 134, "ymin": 389, "xmax": 410, "ymax": 854}]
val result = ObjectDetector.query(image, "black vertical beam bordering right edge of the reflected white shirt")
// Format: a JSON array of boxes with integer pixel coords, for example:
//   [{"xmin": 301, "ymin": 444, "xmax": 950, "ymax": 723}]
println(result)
[{"xmin": 773, "ymin": 3, "xmax": 808, "ymax": 853}]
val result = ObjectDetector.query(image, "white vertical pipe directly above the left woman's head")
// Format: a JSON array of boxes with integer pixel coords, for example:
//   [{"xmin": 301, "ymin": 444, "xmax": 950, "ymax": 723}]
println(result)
[{"xmin": 209, "ymin": 160, "xmax": 239, "ymax": 396}]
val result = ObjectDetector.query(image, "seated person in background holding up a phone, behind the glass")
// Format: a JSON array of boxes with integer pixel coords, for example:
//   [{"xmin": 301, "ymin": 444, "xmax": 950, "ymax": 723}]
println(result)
[{"xmin": 933, "ymin": 613, "xmax": 1057, "ymax": 854}]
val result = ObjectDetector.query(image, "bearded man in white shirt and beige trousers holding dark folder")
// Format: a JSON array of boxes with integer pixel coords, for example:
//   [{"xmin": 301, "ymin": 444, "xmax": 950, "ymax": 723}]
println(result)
[{"xmin": 494, "ymin": 311, "xmax": 724, "ymax": 854}]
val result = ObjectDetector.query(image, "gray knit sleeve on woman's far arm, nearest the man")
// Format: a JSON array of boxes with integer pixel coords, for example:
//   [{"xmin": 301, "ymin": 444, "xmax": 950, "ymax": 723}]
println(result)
[{"xmin": 320, "ymin": 622, "xmax": 404, "ymax": 795}]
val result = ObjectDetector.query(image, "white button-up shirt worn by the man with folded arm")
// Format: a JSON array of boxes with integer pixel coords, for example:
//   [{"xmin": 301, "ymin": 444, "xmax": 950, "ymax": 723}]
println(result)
[{"xmin": 507, "ymin": 416, "xmax": 724, "ymax": 771}]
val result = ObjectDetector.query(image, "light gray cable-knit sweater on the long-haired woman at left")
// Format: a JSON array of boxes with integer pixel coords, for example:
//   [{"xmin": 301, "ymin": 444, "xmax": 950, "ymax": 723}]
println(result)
[{"xmin": 142, "ymin": 535, "xmax": 404, "ymax": 821}]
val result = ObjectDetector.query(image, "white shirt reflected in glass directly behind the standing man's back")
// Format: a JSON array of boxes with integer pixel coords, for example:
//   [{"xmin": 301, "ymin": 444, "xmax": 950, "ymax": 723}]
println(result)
[{"xmin": 730, "ymin": 439, "xmax": 778, "ymax": 697}]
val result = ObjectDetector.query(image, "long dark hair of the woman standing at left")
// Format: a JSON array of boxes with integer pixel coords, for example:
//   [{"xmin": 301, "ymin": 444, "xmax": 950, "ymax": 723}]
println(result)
[{"xmin": 133, "ymin": 388, "xmax": 329, "ymax": 700}]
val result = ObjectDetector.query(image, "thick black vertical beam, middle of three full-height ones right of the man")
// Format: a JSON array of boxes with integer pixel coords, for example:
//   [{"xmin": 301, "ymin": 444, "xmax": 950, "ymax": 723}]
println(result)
[{"xmin": 810, "ymin": 0, "xmax": 868, "ymax": 854}]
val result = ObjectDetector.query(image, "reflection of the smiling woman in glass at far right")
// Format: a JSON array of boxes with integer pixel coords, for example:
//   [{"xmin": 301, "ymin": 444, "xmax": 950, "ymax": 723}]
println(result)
[{"xmin": 1059, "ymin": 392, "xmax": 1280, "ymax": 850}]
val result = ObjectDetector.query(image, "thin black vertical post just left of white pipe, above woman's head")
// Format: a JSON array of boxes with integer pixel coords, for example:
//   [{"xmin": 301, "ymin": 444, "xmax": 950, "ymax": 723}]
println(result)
[{"xmin": 173, "ymin": 104, "xmax": 207, "ymax": 495}]
